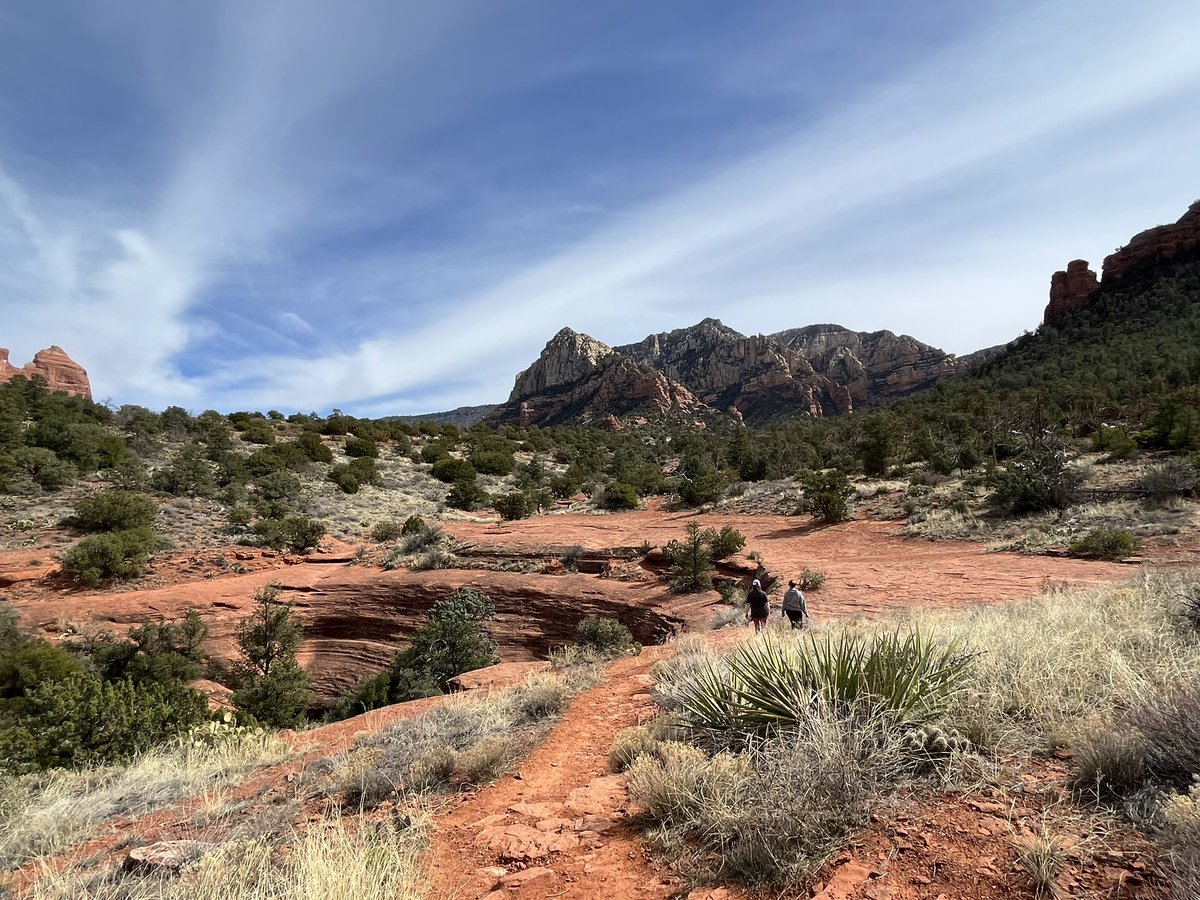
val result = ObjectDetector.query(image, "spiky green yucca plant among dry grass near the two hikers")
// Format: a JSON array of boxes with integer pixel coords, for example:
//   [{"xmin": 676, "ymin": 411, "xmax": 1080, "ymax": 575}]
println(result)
[{"xmin": 677, "ymin": 629, "xmax": 971, "ymax": 734}]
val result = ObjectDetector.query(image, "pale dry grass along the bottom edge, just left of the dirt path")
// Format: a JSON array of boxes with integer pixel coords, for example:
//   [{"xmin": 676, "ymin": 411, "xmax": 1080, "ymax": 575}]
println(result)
[{"xmin": 30, "ymin": 814, "xmax": 428, "ymax": 900}]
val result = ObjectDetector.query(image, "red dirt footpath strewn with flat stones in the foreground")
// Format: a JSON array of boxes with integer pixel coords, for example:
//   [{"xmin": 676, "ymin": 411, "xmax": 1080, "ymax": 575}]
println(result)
[{"xmin": 430, "ymin": 648, "xmax": 705, "ymax": 900}]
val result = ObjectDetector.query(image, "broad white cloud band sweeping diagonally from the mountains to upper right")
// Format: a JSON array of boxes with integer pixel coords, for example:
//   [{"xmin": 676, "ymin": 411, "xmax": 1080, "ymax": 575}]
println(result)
[{"xmin": 182, "ymin": 5, "xmax": 1200, "ymax": 403}]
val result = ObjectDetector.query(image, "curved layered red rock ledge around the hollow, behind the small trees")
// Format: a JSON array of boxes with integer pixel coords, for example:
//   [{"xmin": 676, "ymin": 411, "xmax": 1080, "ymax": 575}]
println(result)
[{"xmin": 14, "ymin": 564, "xmax": 691, "ymax": 702}]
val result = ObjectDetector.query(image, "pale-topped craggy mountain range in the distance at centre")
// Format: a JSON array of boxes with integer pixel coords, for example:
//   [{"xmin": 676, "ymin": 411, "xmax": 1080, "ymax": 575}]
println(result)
[{"xmin": 492, "ymin": 319, "xmax": 965, "ymax": 425}]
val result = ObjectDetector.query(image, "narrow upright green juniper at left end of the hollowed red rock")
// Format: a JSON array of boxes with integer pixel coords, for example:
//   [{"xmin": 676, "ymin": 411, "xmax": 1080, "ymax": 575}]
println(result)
[{"xmin": 233, "ymin": 584, "xmax": 312, "ymax": 728}]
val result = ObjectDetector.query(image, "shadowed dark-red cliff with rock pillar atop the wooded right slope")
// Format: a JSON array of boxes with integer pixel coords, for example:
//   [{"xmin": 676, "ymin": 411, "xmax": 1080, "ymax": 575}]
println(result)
[{"xmin": 1043, "ymin": 200, "xmax": 1200, "ymax": 325}]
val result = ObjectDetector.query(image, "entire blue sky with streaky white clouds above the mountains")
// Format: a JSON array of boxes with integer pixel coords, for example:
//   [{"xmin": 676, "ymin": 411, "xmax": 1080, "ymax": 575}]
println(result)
[{"xmin": 0, "ymin": 0, "xmax": 1200, "ymax": 415}]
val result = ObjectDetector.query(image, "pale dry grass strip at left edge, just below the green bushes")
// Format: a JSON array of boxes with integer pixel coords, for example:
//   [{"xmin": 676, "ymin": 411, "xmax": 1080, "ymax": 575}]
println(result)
[{"xmin": 0, "ymin": 732, "xmax": 290, "ymax": 866}]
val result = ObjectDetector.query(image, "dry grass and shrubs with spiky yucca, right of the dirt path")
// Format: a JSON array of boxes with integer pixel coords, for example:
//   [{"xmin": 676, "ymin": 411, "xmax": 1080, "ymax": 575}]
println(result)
[{"xmin": 610, "ymin": 575, "xmax": 1200, "ymax": 899}]
